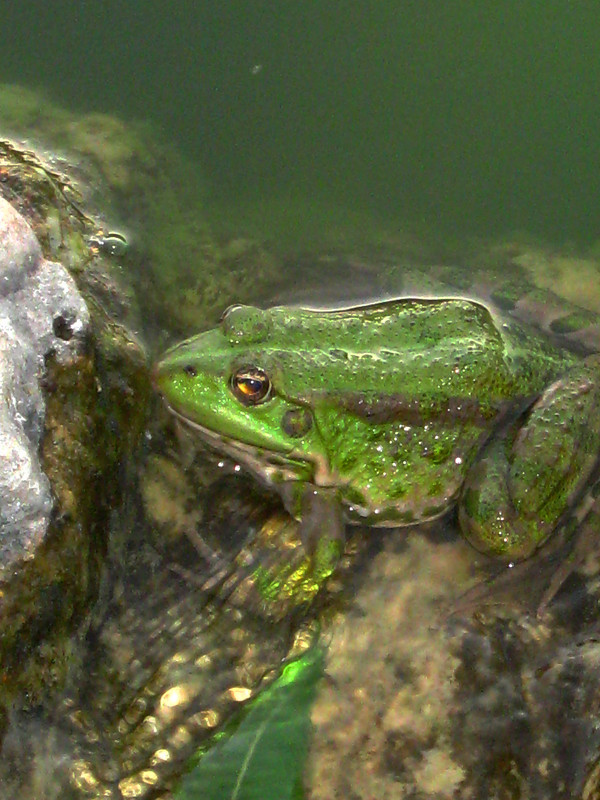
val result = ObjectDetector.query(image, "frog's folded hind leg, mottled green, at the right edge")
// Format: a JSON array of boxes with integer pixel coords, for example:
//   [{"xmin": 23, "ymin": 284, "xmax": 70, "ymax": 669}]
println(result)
[{"xmin": 459, "ymin": 355, "xmax": 600, "ymax": 559}]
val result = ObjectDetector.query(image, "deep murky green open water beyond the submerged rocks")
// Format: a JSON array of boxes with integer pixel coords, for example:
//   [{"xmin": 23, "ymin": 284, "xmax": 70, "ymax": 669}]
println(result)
[{"xmin": 0, "ymin": 0, "xmax": 600, "ymax": 241}]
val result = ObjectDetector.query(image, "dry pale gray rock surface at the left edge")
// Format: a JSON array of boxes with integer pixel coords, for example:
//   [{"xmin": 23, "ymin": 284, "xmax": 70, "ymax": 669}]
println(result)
[{"xmin": 0, "ymin": 198, "xmax": 89, "ymax": 570}]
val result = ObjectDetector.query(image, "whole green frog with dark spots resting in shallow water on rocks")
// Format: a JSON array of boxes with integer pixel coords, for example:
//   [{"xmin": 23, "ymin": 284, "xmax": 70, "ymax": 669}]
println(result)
[{"xmin": 154, "ymin": 298, "xmax": 600, "ymax": 560}]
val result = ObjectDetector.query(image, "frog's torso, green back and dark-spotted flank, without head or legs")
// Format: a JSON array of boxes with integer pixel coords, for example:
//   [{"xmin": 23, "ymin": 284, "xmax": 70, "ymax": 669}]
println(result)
[{"xmin": 273, "ymin": 298, "xmax": 576, "ymax": 525}]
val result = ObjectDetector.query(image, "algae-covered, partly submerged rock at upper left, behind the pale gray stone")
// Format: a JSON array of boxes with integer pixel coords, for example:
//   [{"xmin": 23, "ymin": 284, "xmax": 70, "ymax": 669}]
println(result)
[{"xmin": 0, "ymin": 86, "xmax": 282, "ymax": 340}]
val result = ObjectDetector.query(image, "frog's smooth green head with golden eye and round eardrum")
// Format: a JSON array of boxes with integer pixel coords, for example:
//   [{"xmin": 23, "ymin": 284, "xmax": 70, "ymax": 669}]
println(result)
[{"xmin": 153, "ymin": 306, "xmax": 327, "ymax": 478}]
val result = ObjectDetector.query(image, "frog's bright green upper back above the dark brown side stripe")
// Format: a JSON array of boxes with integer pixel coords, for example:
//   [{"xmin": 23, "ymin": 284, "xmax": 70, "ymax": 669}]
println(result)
[{"xmin": 269, "ymin": 298, "xmax": 573, "ymax": 407}]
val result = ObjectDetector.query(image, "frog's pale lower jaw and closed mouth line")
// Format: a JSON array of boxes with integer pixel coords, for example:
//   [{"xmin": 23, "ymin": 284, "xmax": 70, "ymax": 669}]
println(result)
[{"xmin": 167, "ymin": 405, "xmax": 318, "ymax": 486}]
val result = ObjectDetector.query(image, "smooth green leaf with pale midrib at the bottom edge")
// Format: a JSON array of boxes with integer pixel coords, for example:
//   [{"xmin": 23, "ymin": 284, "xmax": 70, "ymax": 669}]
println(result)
[{"xmin": 175, "ymin": 647, "xmax": 324, "ymax": 800}]
